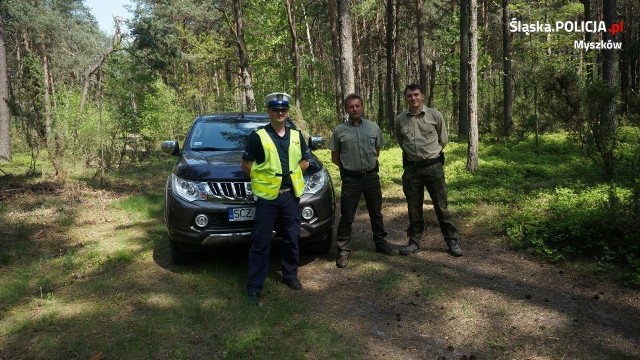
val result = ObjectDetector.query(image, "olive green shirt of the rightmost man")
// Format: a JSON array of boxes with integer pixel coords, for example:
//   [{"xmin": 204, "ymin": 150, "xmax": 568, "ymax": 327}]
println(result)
[{"xmin": 395, "ymin": 106, "xmax": 449, "ymax": 161}]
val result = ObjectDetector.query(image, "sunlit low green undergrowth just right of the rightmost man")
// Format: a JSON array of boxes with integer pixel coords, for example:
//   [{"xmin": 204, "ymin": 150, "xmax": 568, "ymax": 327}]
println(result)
[{"xmin": 445, "ymin": 133, "xmax": 602, "ymax": 206}]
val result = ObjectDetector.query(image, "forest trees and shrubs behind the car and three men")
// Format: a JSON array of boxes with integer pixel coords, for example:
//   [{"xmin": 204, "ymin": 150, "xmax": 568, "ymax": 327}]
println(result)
[{"xmin": 0, "ymin": 0, "xmax": 640, "ymax": 283}]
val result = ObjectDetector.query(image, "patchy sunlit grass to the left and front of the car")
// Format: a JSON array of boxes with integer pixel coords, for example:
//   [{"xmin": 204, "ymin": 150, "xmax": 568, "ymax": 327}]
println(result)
[{"xmin": 0, "ymin": 155, "xmax": 359, "ymax": 359}]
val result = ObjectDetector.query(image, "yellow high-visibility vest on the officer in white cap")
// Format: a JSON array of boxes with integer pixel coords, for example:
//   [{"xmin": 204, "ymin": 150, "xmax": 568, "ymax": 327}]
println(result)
[{"xmin": 251, "ymin": 128, "xmax": 304, "ymax": 200}]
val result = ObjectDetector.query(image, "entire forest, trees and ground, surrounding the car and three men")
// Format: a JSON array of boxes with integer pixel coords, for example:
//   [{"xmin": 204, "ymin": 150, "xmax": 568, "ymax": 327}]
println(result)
[{"xmin": 0, "ymin": 0, "xmax": 640, "ymax": 360}]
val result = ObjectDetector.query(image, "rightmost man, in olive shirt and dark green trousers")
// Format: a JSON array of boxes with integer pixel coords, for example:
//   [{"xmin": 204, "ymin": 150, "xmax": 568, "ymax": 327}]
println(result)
[{"xmin": 395, "ymin": 84, "xmax": 462, "ymax": 256}]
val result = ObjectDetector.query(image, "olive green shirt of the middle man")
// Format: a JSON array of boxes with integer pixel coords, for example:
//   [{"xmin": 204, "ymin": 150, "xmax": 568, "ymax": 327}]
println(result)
[{"xmin": 328, "ymin": 119, "xmax": 384, "ymax": 171}]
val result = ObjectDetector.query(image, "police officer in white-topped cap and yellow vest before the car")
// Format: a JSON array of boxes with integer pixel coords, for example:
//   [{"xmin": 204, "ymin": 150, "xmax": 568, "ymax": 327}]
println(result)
[{"xmin": 241, "ymin": 93, "xmax": 311, "ymax": 304}]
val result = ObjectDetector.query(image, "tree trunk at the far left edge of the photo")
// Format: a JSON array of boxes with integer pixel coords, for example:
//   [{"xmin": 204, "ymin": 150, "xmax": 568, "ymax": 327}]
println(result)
[{"xmin": 0, "ymin": 16, "xmax": 11, "ymax": 161}]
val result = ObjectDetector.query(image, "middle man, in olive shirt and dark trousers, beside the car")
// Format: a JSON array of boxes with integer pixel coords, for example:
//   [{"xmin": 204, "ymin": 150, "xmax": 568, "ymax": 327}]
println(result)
[{"xmin": 329, "ymin": 94, "xmax": 393, "ymax": 268}]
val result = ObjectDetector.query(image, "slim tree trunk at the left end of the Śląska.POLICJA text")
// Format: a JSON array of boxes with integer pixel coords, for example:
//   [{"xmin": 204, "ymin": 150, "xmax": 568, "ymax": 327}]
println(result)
[{"xmin": 502, "ymin": 0, "xmax": 513, "ymax": 137}]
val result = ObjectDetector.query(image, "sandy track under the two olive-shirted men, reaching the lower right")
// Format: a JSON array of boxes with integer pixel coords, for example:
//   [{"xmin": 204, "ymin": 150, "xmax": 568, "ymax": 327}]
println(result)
[{"xmin": 292, "ymin": 204, "xmax": 640, "ymax": 359}]
